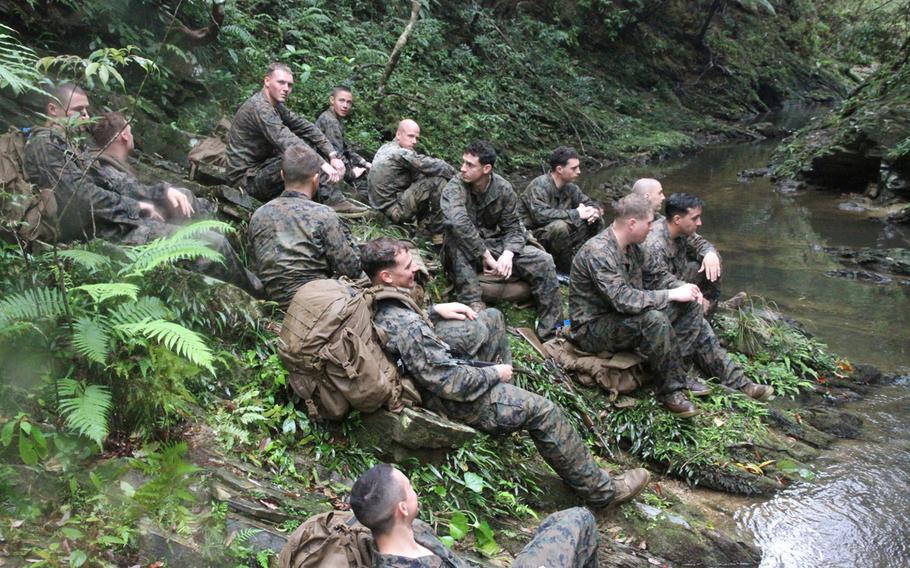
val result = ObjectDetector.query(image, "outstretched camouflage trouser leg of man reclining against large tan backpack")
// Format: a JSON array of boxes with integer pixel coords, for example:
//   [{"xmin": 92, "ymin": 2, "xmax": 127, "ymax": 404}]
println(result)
[{"xmin": 431, "ymin": 383, "xmax": 614, "ymax": 507}]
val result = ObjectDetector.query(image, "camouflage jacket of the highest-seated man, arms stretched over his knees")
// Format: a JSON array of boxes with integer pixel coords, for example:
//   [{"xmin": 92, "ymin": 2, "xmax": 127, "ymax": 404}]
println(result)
[{"xmin": 225, "ymin": 91, "xmax": 335, "ymax": 184}]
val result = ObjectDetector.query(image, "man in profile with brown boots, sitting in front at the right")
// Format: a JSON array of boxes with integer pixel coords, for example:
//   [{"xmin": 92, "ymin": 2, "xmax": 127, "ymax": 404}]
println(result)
[{"xmin": 569, "ymin": 193, "xmax": 773, "ymax": 417}]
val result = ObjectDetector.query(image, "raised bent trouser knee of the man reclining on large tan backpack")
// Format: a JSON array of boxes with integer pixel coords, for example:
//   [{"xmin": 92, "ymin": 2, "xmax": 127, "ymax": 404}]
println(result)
[{"xmin": 433, "ymin": 308, "xmax": 512, "ymax": 365}]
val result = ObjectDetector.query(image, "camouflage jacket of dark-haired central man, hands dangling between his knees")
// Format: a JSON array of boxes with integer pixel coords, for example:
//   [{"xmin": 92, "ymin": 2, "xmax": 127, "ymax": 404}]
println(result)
[{"xmin": 439, "ymin": 173, "xmax": 527, "ymax": 260}]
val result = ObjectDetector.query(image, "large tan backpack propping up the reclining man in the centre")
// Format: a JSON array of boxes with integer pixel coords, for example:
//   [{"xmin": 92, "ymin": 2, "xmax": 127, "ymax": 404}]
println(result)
[{"xmin": 278, "ymin": 279, "xmax": 420, "ymax": 420}]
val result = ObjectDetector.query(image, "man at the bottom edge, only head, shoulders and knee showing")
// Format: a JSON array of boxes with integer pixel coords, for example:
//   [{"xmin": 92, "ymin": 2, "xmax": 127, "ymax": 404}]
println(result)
[{"xmin": 351, "ymin": 463, "xmax": 598, "ymax": 568}]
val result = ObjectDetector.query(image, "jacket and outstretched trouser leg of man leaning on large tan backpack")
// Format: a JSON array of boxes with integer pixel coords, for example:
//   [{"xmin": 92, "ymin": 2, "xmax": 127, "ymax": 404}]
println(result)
[{"xmin": 375, "ymin": 300, "xmax": 614, "ymax": 506}]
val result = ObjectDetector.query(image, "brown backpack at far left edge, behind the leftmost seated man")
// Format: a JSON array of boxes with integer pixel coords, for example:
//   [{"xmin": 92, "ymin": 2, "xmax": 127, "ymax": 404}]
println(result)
[{"xmin": 0, "ymin": 127, "xmax": 57, "ymax": 242}]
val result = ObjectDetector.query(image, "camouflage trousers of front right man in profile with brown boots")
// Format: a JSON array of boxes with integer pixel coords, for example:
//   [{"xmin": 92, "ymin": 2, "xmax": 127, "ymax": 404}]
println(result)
[{"xmin": 572, "ymin": 302, "xmax": 748, "ymax": 397}]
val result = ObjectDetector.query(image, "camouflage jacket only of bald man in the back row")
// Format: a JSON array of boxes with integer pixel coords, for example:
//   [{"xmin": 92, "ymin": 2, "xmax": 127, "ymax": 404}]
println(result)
[{"xmin": 367, "ymin": 140, "xmax": 455, "ymax": 210}]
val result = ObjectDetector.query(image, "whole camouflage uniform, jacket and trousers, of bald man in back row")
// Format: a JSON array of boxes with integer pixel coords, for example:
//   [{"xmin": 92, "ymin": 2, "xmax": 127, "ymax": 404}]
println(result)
[{"xmin": 367, "ymin": 140, "xmax": 455, "ymax": 224}]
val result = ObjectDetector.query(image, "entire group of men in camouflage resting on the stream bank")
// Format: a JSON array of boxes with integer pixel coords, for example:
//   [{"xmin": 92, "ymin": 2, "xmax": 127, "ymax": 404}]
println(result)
[{"xmin": 24, "ymin": 63, "xmax": 772, "ymax": 567}]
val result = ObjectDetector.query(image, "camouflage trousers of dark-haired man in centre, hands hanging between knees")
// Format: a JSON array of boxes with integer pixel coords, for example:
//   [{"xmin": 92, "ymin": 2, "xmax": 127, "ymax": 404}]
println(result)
[{"xmin": 445, "ymin": 239, "xmax": 564, "ymax": 339}]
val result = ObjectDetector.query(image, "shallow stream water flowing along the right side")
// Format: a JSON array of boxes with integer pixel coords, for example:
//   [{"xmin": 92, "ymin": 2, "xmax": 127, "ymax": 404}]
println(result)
[{"xmin": 584, "ymin": 135, "xmax": 910, "ymax": 568}]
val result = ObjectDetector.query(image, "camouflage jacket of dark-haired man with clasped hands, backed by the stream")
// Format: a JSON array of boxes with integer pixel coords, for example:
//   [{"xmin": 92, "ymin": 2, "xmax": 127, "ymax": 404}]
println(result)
[{"xmin": 521, "ymin": 174, "xmax": 600, "ymax": 229}]
